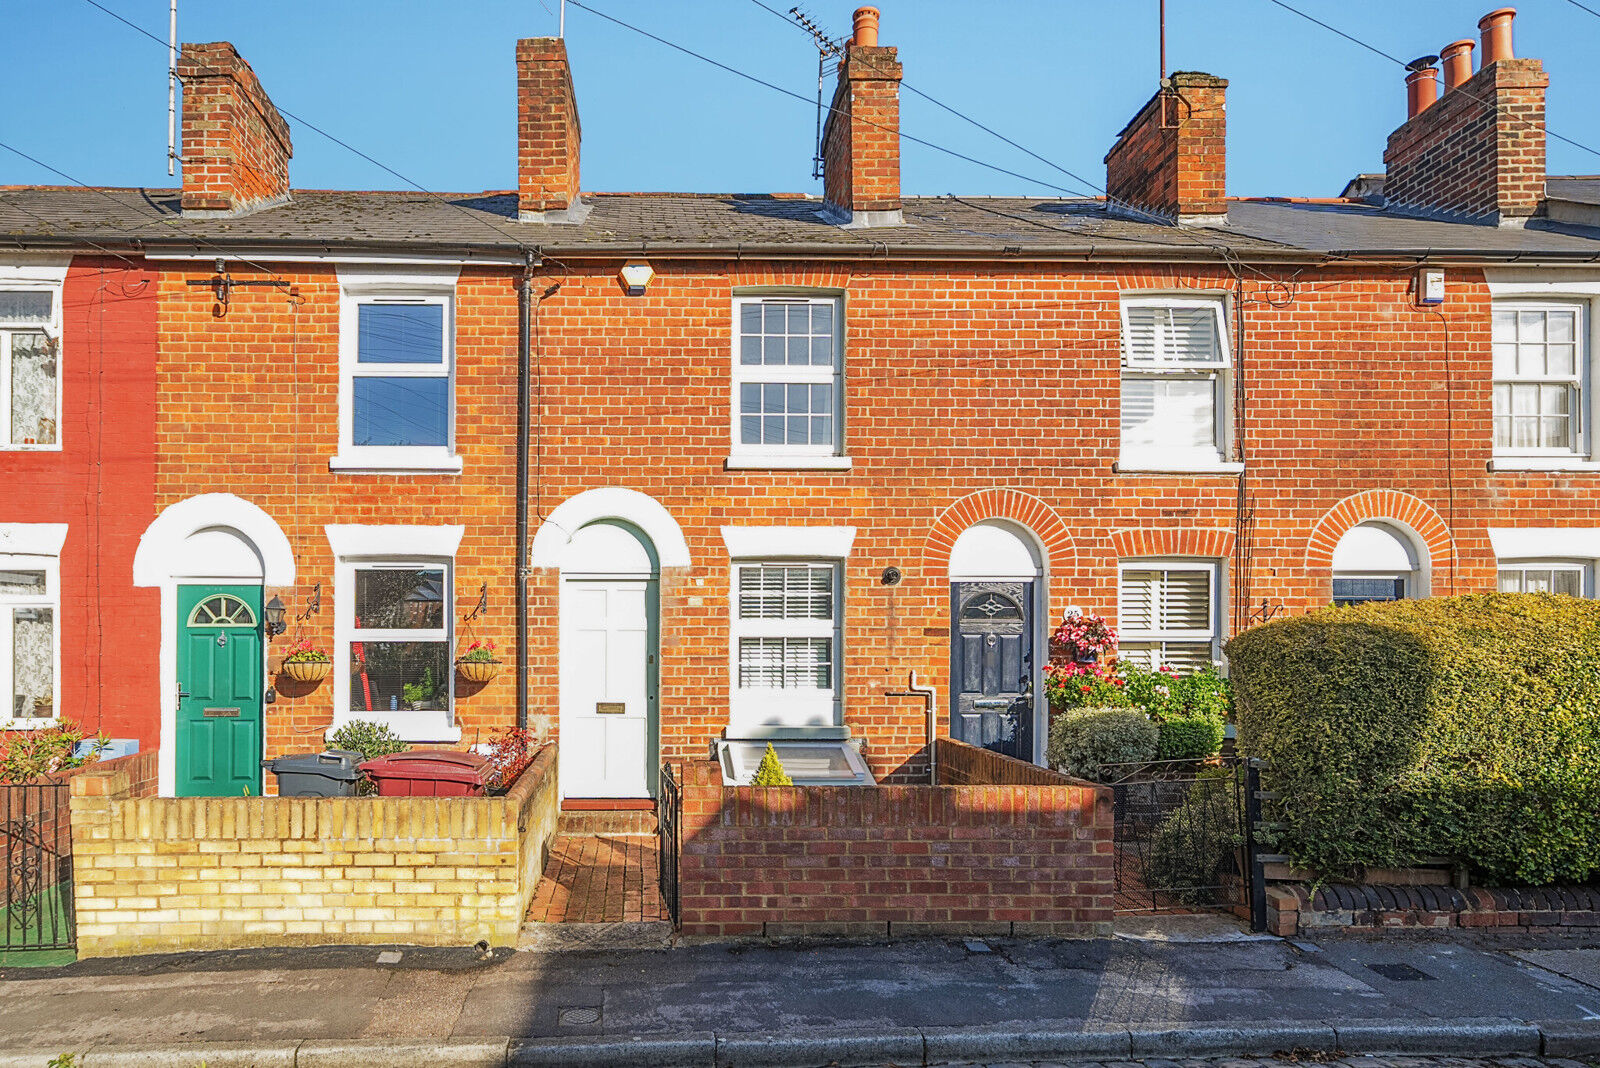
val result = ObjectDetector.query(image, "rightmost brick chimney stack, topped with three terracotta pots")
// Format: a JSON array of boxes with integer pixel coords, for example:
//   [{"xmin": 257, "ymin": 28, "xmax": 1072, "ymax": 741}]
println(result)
[{"xmin": 1384, "ymin": 8, "xmax": 1550, "ymax": 225}]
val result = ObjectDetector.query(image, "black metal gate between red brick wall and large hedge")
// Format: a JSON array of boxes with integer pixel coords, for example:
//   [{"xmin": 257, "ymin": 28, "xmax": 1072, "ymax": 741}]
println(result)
[{"xmin": 1101, "ymin": 756, "xmax": 1266, "ymax": 921}]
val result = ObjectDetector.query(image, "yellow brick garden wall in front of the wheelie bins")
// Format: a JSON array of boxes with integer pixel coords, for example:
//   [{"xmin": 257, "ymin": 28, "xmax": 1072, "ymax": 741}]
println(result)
[{"xmin": 72, "ymin": 745, "xmax": 558, "ymax": 958}]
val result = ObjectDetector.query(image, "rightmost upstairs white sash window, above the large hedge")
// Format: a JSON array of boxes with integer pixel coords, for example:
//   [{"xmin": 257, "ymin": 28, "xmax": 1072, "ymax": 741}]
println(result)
[{"xmin": 1493, "ymin": 301, "xmax": 1589, "ymax": 457}]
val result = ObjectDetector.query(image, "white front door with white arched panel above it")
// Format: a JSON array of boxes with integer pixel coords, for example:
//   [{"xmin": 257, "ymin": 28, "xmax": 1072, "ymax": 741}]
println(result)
[{"xmin": 557, "ymin": 518, "xmax": 661, "ymax": 801}]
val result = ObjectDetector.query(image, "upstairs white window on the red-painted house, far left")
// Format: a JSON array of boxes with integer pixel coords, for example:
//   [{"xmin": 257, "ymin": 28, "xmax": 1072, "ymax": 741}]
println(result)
[{"xmin": 0, "ymin": 283, "xmax": 61, "ymax": 449}]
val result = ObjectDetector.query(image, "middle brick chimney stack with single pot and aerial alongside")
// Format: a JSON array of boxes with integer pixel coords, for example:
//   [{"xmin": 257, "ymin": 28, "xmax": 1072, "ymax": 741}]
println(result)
[{"xmin": 822, "ymin": 8, "xmax": 904, "ymax": 227}]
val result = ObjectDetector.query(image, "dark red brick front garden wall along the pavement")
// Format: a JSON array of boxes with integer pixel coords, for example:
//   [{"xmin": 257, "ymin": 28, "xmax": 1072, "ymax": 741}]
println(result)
[{"xmin": 678, "ymin": 761, "xmax": 1112, "ymax": 935}]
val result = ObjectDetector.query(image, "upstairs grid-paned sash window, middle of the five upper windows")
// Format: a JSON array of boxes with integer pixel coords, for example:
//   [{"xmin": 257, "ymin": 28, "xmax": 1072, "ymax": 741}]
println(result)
[{"xmin": 733, "ymin": 297, "xmax": 843, "ymax": 457}]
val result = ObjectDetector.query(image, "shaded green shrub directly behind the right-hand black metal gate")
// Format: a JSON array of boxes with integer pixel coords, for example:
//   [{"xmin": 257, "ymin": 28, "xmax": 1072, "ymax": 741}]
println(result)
[{"xmin": 1141, "ymin": 769, "xmax": 1243, "ymax": 905}]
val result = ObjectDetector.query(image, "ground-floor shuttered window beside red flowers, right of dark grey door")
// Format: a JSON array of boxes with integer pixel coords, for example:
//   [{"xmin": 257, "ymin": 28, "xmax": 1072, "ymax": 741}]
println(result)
[{"xmin": 1117, "ymin": 560, "xmax": 1219, "ymax": 673}]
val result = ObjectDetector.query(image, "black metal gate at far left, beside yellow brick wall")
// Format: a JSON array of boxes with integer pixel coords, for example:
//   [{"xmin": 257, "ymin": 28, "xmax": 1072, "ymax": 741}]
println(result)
[{"xmin": 0, "ymin": 783, "xmax": 74, "ymax": 950}]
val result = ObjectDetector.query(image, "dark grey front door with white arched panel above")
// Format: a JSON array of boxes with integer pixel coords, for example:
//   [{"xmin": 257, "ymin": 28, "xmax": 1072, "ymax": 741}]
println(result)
[{"xmin": 949, "ymin": 520, "xmax": 1050, "ymax": 764}]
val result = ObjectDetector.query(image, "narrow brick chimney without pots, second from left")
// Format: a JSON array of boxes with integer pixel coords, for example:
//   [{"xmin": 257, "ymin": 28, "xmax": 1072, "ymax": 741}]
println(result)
[{"xmin": 517, "ymin": 37, "xmax": 584, "ymax": 222}]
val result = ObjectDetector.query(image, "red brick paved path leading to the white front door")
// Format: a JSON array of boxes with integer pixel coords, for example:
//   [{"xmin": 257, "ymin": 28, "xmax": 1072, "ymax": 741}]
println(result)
[{"xmin": 528, "ymin": 835, "xmax": 666, "ymax": 924}]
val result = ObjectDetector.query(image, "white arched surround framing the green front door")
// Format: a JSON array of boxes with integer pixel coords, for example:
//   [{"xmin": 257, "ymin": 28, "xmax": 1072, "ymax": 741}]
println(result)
[{"xmin": 133, "ymin": 492, "xmax": 294, "ymax": 796}]
